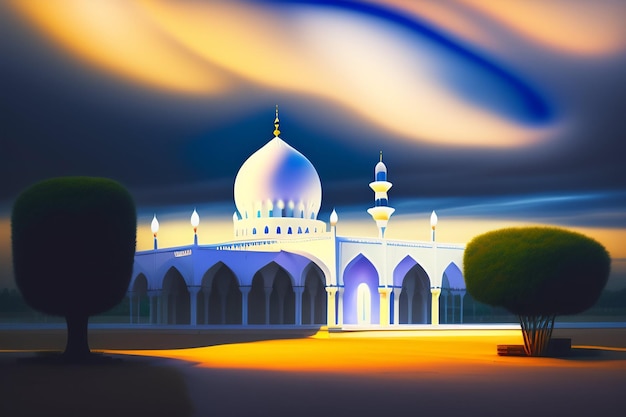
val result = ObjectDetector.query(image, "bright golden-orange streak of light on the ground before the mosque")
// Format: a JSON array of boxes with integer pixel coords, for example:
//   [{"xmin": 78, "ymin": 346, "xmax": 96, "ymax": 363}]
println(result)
[{"xmin": 107, "ymin": 329, "xmax": 626, "ymax": 378}]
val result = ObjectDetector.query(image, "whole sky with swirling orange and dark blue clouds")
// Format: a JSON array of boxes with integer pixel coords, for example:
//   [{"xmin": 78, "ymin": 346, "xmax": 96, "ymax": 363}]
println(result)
[{"xmin": 0, "ymin": 0, "xmax": 626, "ymax": 289}]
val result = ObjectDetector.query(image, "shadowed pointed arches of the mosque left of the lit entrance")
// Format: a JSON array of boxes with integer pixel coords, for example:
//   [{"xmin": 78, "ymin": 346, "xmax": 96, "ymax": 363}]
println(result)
[{"xmin": 129, "ymin": 262, "xmax": 326, "ymax": 325}]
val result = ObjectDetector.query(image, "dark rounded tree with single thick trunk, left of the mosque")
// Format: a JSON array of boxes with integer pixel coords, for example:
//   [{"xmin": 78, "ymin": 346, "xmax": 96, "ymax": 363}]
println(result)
[{"xmin": 11, "ymin": 177, "xmax": 137, "ymax": 358}]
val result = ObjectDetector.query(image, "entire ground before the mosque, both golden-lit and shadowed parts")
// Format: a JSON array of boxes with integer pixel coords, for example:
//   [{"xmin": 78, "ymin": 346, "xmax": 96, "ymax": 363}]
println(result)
[{"xmin": 0, "ymin": 328, "xmax": 626, "ymax": 417}]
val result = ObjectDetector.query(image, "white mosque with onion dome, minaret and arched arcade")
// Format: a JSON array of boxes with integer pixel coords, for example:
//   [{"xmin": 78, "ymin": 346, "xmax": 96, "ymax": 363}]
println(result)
[{"xmin": 128, "ymin": 108, "xmax": 465, "ymax": 327}]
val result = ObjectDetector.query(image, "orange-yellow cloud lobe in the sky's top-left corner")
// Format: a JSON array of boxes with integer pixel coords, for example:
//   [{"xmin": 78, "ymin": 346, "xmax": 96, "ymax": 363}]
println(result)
[{"xmin": 10, "ymin": 0, "xmax": 229, "ymax": 94}]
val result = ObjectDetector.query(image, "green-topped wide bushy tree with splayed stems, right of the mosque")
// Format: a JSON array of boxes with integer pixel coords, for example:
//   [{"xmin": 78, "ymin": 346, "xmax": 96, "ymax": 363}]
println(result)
[{"xmin": 463, "ymin": 227, "xmax": 611, "ymax": 356}]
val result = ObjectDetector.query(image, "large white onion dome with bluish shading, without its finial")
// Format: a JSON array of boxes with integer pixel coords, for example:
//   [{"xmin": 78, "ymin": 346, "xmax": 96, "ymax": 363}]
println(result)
[{"xmin": 235, "ymin": 136, "xmax": 322, "ymax": 219}]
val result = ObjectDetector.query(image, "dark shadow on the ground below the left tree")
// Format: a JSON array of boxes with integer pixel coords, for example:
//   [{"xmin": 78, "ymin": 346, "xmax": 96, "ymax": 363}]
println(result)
[{"xmin": 0, "ymin": 353, "xmax": 193, "ymax": 417}]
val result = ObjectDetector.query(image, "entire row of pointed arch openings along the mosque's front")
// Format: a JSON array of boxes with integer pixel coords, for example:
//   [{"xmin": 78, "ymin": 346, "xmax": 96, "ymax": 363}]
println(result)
[{"xmin": 129, "ymin": 256, "xmax": 465, "ymax": 325}]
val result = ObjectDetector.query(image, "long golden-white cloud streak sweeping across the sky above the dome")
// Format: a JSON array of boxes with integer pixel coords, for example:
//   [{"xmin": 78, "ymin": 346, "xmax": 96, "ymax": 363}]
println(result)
[{"xmin": 11, "ymin": 0, "xmax": 562, "ymax": 147}]
